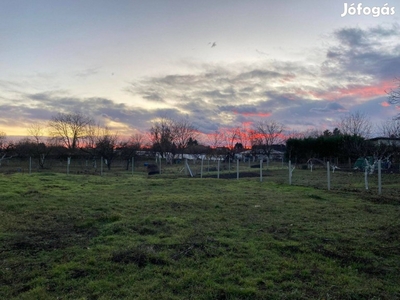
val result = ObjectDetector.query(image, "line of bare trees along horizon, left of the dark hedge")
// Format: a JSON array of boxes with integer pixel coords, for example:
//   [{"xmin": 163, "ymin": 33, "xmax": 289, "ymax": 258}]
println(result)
[{"xmin": 0, "ymin": 112, "xmax": 285, "ymax": 169}]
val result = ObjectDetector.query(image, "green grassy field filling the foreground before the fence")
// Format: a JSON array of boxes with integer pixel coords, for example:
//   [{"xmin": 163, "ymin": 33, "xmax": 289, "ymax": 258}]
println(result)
[{"xmin": 0, "ymin": 170, "xmax": 400, "ymax": 299}]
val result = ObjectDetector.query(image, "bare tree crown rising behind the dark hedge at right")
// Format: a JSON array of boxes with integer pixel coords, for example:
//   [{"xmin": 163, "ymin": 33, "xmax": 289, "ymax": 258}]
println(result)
[{"xmin": 338, "ymin": 111, "xmax": 372, "ymax": 138}]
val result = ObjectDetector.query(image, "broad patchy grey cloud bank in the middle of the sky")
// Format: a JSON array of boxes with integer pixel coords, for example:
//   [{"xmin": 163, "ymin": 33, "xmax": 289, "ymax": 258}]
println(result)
[{"xmin": 126, "ymin": 58, "xmax": 346, "ymax": 132}]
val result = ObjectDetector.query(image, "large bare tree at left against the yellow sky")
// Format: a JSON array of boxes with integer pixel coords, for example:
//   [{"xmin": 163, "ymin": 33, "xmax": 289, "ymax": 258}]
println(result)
[{"xmin": 49, "ymin": 112, "xmax": 94, "ymax": 152}]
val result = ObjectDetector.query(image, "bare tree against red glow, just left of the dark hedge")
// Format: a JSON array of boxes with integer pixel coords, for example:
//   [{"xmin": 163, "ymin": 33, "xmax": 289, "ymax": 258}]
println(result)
[{"xmin": 251, "ymin": 120, "xmax": 285, "ymax": 157}]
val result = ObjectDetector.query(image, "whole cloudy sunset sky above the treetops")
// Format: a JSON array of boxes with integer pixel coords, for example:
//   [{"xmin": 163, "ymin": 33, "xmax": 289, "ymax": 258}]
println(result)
[{"xmin": 0, "ymin": 0, "xmax": 400, "ymax": 136}]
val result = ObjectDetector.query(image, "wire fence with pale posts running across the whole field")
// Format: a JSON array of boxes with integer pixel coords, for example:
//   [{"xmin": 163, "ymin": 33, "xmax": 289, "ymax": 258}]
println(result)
[{"xmin": 0, "ymin": 157, "xmax": 400, "ymax": 198}]
